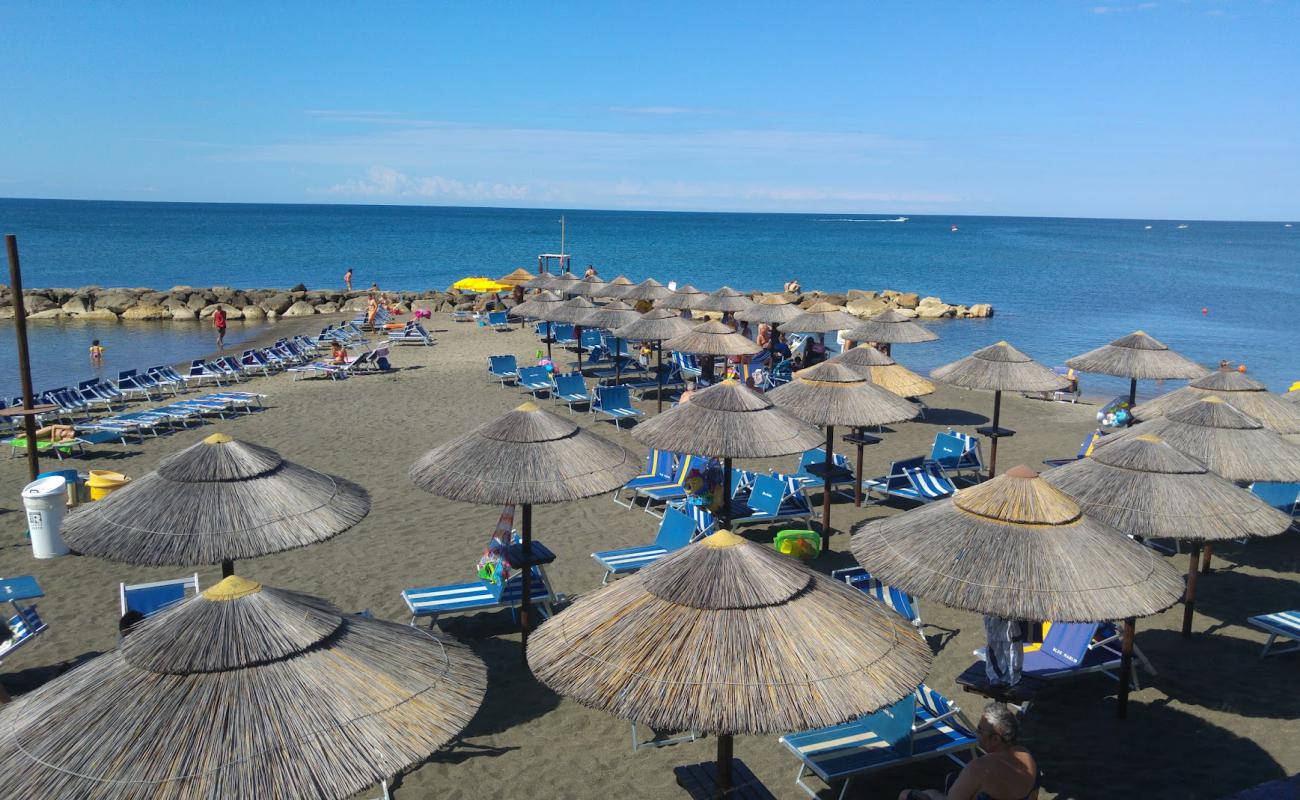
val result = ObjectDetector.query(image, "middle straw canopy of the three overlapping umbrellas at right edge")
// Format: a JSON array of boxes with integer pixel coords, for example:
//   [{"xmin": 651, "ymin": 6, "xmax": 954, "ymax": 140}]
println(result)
[{"xmin": 1093, "ymin": 395, "xmax": 1300, "ymax": 483}]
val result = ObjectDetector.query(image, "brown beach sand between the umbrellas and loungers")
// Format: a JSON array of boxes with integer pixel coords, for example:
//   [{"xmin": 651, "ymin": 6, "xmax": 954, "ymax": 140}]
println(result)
[{"xmin": 0, "ymin": 315, "xmax": 1300, "ymax": 797}]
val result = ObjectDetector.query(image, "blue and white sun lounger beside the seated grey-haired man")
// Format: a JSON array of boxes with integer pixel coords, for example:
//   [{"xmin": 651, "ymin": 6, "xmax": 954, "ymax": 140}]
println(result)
[{"xmin": 780, "ymin": 684, "xmax": 976, "ymax": 800}]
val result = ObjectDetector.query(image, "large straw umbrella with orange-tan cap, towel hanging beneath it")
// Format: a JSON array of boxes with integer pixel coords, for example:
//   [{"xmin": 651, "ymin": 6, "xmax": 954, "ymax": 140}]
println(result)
[{"xmin": 853, "ymin": 466, "xmax": 1183, "ymax": 718}]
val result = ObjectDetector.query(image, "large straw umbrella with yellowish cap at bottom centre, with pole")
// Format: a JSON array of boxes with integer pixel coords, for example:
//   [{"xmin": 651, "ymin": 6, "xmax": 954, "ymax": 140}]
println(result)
[{"xmin": 528, "ymin": 528, "xmax": 931, "ymax": 796}]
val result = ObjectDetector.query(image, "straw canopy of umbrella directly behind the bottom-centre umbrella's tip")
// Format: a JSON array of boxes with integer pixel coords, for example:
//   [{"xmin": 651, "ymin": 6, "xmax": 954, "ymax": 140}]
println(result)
[{"xmin": 632, "ymin": 380, "xmax": 822, "ymax": 458}]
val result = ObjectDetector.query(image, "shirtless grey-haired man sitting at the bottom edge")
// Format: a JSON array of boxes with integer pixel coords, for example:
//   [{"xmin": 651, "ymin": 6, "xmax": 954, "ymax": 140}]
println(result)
[{"xmin": 898, "ymin": 702, "xmax": 1039, "ymax": 800}]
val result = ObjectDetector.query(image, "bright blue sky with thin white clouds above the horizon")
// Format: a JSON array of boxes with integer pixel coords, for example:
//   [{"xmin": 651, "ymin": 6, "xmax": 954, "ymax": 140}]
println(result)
[{"xmin": 0, "ymin": 0, "xmax": 1300, "ymax": 220}]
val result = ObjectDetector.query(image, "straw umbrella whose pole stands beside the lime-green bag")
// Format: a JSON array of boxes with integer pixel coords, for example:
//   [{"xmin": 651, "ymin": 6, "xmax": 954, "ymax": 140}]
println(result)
[{"xmin": 767, "ymin": 362, "xmax": 918, "ymax": 553}]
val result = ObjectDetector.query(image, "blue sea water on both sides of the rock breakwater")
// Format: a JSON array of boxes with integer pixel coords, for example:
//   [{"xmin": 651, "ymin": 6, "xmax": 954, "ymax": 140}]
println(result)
[{"xmin": 0, "ymin": 199, "xmax": 1300, "ymax": 394}]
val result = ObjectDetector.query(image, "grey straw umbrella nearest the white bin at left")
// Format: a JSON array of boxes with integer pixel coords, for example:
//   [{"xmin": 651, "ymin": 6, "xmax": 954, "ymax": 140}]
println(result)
[{"xmin": 62, "ymin": 433, "xmax": 371, "ymax": 575}]
